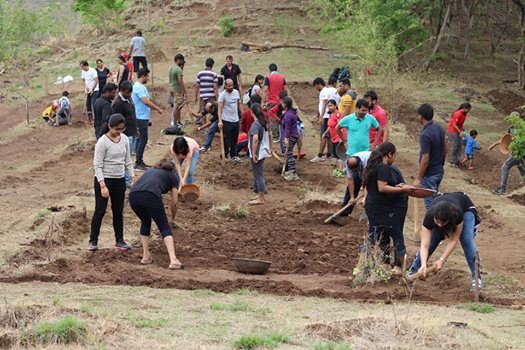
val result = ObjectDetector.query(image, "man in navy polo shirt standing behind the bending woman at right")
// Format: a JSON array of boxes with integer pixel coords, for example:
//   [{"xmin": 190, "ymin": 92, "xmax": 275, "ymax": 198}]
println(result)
[{"xmin": 414, "ymin": 103, "xmax": 447, "ymax": 209}]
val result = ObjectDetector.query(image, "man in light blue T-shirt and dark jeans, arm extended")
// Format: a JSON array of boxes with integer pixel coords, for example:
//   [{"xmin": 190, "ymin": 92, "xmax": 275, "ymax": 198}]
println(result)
[{"xmin": 131, "ymin": 68, "xmax": 162, "ymax": 170}]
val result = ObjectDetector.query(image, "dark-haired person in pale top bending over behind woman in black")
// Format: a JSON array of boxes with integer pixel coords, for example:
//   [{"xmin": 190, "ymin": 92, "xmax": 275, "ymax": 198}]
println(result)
[{"xmin": 170, "ymin": 136, "xmax": 200, "ymax": 187}]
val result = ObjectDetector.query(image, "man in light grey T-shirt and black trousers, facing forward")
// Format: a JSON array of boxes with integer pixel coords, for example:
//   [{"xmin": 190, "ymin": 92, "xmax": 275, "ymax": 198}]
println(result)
[{"xmin": 218, "ymin": 79, "xmax": 242, "ymax": 163}]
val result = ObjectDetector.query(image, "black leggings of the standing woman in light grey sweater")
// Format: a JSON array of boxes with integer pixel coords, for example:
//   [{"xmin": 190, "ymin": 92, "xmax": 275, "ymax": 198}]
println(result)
[{"xmin": 89, "ymin": 177, "xmax": 126, "ymax": 244}]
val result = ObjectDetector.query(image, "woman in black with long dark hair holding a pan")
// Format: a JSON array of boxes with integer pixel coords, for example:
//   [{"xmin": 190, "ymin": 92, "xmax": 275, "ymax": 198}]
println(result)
[{"xmin": 364, "ymin": 142, "xmax": 413, "ymax": 274}]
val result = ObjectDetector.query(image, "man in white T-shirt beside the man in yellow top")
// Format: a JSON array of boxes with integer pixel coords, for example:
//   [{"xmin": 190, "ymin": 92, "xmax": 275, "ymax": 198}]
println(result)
[{"xmin": 310, "ymin": 78, "xmax": 339, "ymax": 163}]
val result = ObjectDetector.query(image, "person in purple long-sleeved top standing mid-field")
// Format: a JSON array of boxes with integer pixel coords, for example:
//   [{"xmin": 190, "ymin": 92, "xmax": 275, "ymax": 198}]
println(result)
[{"xmin": 281, "ymin": 96, "xmax": 299, "ymax": 181}]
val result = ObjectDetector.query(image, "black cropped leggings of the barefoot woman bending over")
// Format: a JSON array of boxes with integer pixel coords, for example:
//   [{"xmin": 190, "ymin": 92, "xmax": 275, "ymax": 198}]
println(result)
[{"xmin": 129, "ymin": 191, "xmax": 173, "ymax": 238}]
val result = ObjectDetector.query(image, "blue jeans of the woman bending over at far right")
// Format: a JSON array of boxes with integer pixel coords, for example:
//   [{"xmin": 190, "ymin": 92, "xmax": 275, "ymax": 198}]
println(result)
[{"xmin": 409, "ymin": 211, "xmax": 481, "ymax": 278}]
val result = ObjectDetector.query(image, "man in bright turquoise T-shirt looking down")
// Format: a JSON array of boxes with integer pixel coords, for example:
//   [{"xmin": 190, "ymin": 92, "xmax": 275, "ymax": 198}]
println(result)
[{"xmin": 337, "ymin": 99, "xmax": 382, "ymax": 156}]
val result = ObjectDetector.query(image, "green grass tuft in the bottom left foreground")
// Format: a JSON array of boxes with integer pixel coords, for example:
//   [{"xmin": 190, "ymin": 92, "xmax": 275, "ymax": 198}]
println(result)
[{"xmin": 33, "ymin": 316, "xmax": 87, "ymax": 344}]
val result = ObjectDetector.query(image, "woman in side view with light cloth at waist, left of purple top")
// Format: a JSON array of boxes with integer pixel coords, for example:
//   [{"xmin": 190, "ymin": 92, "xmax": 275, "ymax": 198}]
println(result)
[{"xmin": 248, "ymin": 103, "xmax": 272, "ymax": 205}]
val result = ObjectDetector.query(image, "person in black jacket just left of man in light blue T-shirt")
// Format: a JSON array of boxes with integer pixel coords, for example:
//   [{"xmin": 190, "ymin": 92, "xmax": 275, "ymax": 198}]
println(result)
[{"xmin": 113, "ymin": 80, "xmax": 139, "ymax": 188}]
